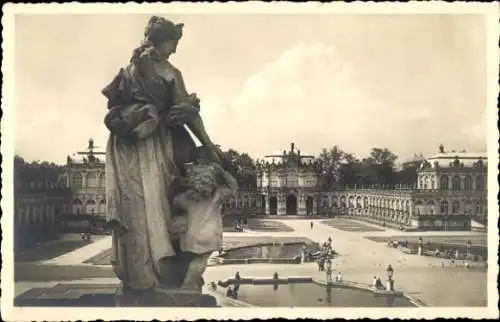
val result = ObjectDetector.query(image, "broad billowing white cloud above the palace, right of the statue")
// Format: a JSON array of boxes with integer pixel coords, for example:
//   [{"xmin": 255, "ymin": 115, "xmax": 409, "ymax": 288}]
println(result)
[{"xmin": 206, "ymin": 43, "xmax": 486, "ymax": 159}]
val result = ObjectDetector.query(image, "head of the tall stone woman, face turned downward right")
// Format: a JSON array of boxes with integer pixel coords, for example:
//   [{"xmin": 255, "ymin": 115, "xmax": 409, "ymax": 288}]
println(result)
[{"xmin": 144, "ymin": 16, "xmax": 184, "ymax": 57}]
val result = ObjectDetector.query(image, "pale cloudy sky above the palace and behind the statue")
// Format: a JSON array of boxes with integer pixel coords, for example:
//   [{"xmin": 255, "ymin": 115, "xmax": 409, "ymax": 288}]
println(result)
[{"xmin": 14, "ymin": 14, "xmax": 487, "ymax": 163}]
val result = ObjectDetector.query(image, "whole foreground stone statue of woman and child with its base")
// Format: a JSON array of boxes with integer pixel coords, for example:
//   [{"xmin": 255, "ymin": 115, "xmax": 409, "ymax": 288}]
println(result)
[{"xmin": 102, "ymin": 16, "xmax": 237, "ymax": 306}]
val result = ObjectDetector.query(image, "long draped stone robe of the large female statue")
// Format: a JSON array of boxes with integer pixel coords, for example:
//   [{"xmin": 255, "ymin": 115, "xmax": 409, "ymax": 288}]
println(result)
[{"xmin": 102, "ymin": 54, "xmax": 203, "ymax": 290}]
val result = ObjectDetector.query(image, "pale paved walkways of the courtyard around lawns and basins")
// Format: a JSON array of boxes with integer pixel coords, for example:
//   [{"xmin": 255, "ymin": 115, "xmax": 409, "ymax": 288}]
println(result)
[{"xmin": 15, "ymin": 218, "xmax": 487, "ymax": 306}]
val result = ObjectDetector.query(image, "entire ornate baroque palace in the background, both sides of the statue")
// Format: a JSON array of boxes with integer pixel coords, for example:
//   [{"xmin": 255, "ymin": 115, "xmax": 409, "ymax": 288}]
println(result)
[{"xmin": 26, "ymin": 140, "xmax": 487, "ymax": 231}]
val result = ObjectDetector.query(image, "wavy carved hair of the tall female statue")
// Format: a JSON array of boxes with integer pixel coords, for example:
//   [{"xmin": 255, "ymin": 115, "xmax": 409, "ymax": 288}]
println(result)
[{"xmin": 130, "ymin": 16, "xmax": 184, "ymax": 62}]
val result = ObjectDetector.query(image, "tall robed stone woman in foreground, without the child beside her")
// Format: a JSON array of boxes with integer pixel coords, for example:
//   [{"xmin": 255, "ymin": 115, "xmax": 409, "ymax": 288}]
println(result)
[{"xmin": 102, "ymin": 16, "xmax": 232, "ymax": 305}]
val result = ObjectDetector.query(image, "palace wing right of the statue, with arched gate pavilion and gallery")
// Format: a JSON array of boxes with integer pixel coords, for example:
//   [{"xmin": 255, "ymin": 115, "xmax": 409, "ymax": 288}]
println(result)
[{"xmin": 225, "ymin": 143, "xmax": 488, "ymax": 230}]
